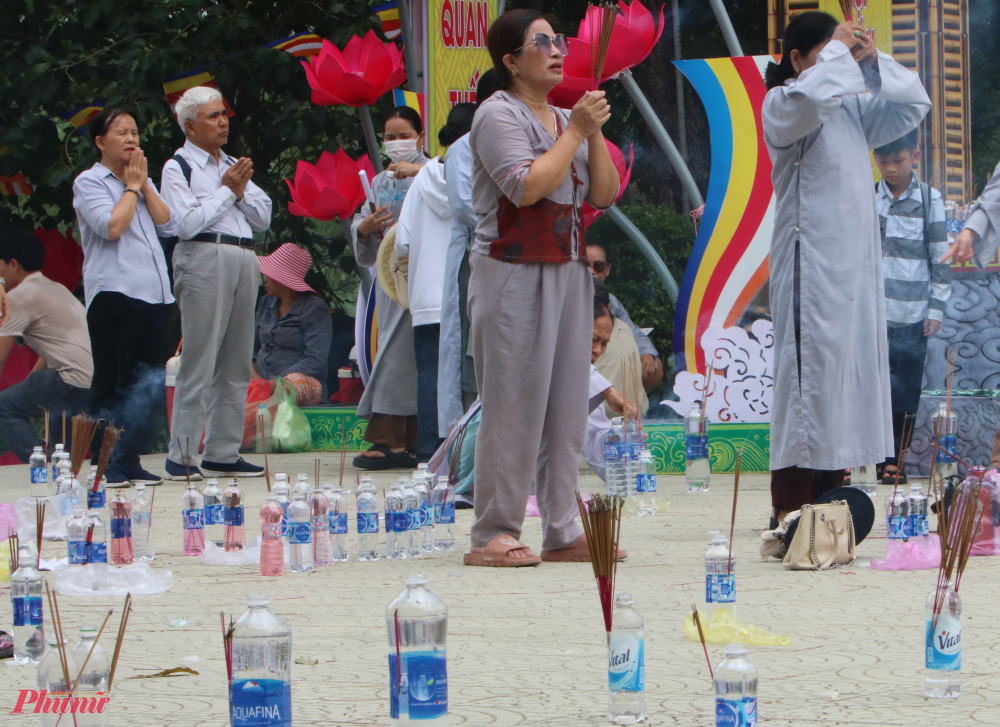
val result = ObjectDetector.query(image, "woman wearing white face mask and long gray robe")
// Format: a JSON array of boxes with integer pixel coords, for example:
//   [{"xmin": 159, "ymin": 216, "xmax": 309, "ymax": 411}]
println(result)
[{"xmin": 351, "ymin": 106, "xmax": 427, "ymax": 470}]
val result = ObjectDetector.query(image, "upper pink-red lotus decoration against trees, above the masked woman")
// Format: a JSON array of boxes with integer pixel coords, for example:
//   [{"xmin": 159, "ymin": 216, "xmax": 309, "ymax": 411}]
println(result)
[{"xmin": 302, "ymin": 30, "xmax": 406, "ymax": 108}]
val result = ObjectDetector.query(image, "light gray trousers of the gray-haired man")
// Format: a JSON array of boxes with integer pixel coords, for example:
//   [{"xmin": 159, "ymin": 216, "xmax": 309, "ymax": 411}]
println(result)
[{"xmin": 168, "ymin": 242, "xmax": 260, "ymax": 464}]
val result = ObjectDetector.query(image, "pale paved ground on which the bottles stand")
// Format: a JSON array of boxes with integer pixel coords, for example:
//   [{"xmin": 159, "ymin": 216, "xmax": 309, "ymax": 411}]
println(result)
[{"xmin": 0, "ymin": 455, "xmax": 1000, "ymax": 727}]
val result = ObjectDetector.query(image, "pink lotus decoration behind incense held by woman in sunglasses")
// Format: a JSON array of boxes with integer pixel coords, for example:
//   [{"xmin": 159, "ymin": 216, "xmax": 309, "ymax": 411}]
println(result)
[{"xmin": 549, "ymin": 0, "xmax": 663, "ymax": 109}]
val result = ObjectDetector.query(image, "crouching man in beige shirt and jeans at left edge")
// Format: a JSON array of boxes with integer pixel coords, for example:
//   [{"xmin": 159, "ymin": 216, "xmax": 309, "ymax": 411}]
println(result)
[{"xmin": 0, "ymin": 229, "xmax": 94, "ymax": 462}]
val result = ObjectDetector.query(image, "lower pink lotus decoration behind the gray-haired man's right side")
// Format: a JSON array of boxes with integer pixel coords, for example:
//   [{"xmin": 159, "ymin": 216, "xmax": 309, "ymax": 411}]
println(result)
[{"xmin": 285, "ymin": 149, "xmax": 375, "ymax": 221}]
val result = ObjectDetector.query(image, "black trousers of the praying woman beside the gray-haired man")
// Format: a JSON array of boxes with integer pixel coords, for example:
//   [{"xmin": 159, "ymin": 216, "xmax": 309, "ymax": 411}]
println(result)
[{"xmin": 87, "ymin": 292, "xmax": 173, "ymax": 464}]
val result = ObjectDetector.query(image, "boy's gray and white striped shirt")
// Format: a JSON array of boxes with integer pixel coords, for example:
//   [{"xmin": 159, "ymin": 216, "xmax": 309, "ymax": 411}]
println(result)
[{"xmin": 876, "ymin": 173, "xmax": 951, "ymax": 328}]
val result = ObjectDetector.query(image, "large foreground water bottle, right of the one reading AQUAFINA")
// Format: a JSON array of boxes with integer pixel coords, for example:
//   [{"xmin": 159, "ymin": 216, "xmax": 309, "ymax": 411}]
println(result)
[{"xmin": 385, "ymin": 575, "xmax": 448, "ymax": 727}]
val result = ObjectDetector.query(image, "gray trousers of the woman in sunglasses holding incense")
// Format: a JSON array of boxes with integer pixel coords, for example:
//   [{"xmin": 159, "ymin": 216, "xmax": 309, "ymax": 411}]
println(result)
[{"xmin": 469, "ymin": 253, "xmax": 594, "ymax": 550}]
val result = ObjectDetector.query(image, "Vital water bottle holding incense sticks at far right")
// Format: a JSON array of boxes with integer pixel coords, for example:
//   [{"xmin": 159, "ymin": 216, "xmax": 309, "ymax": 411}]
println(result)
[{"xmin": 924, "ymin": 583, "xmax": 962, "ymax": 699}]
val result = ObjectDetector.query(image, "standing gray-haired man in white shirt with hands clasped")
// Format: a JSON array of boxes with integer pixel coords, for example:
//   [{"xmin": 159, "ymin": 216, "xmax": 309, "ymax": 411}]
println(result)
[{"xmin": 161, "ymin": 86, "xmax": 271, "ymax": 480}]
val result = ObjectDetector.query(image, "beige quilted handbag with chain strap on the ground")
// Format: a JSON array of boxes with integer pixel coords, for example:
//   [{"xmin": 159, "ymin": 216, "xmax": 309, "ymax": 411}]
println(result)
[{"xmin": 784, "ymin": 500, "xmax": 854, "ymax": 570}]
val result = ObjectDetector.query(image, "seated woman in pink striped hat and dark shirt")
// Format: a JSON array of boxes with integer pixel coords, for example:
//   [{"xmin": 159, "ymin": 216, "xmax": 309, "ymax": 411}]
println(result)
[{"xmin": 252, "ymin": 242, "xmax": 333, "ymax": 406}]
